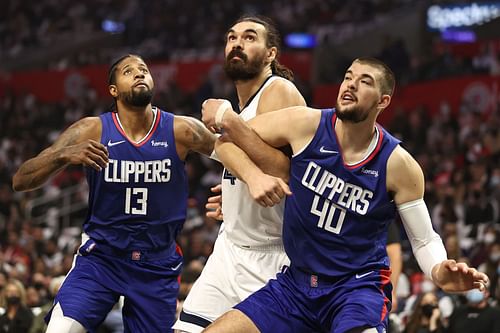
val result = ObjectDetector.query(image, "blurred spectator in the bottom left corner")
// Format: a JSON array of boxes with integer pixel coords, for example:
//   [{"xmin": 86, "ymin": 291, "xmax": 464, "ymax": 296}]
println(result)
[{"xmin": 0, "ymin": 280, "xmax": 33, "ymax": 333}]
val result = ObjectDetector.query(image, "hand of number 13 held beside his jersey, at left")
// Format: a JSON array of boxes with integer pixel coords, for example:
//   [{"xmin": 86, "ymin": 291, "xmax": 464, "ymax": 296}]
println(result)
[{"xmin": 61, "ymin": 139, "xmax": 109, "ymax": 171}]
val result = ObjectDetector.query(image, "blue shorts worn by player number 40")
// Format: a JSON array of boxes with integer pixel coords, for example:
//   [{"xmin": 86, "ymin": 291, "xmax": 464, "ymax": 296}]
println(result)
[{"xmin": 234, "ymin": 267, "xmax": 392, "ymax": 333}]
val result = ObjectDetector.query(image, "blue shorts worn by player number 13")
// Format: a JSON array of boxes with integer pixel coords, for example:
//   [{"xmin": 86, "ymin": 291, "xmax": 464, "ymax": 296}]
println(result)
[{"xmin": 46, "ymin": 240, "xmax": 182, "ymax": 333}]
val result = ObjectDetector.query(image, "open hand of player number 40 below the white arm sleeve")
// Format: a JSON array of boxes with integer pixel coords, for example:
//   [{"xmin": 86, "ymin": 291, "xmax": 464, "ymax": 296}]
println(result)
[{"xmin": 432, "ymin": 259, "xmax": 490, "ymax": 292}]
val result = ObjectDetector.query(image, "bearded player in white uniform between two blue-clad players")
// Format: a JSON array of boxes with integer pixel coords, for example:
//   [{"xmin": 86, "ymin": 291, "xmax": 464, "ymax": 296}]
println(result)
[{"xmin": 174, "ymin": 16, "xmax": 305, "ymax": 333}]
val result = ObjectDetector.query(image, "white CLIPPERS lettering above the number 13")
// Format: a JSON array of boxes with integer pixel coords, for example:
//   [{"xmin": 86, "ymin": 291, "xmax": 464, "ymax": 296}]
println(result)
[{"xmin": 104, "ymin": 158, "xmax": 172, "ymax": 183}]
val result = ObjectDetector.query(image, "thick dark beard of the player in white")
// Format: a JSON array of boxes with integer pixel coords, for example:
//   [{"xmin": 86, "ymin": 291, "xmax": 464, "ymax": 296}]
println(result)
[{"xmin": 224, "ymin": 49, "xmax": 265, "ymax": 81}]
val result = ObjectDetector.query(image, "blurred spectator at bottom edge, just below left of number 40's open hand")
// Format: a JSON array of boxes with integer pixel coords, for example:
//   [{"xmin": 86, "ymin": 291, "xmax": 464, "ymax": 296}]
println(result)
[{"xmin": 405, "ymin": 292, "xmax": 444, "ymax": 333}]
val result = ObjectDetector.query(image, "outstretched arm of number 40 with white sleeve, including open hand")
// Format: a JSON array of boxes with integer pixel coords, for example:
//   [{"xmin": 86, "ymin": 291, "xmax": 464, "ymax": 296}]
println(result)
[{"xmin": 387, "ymin": 147, "xmax": 489, "ymax": 292}]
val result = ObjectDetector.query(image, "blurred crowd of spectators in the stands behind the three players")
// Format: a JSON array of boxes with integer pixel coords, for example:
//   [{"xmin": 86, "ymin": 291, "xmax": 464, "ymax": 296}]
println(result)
[{"xmin": 0, "ymin": 65, "xmax": 500, "ymax": 332}]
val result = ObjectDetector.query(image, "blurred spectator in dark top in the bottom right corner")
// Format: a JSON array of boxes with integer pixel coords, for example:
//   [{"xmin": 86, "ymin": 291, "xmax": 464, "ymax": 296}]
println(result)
[{"xmin": 448, "ymin": 289, "xmax": 500, "ymax": 333}]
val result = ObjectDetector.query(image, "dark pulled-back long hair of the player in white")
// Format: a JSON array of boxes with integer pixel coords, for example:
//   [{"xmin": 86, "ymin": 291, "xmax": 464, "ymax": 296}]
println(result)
[{"xmin": 231, "ymin": 15, "xmax": 293, "ymax": 81}]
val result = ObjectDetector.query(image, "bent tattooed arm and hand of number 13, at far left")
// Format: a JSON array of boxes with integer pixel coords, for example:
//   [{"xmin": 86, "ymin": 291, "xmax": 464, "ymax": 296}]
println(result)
[{"xmin": 12, "ymin": 117, "xmax": 108, "ymax": 191}]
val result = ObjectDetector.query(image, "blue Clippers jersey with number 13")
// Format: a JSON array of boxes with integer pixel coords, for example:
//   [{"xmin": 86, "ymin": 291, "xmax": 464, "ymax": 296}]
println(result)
[{"xmin": 84, "ymin": 109, "xmax": 188, "ymax": 250}]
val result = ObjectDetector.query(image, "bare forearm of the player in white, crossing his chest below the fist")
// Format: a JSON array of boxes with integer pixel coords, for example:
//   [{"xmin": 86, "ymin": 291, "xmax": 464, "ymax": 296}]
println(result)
[{"xmin": 223, "ymin": 113, "xmax": 290, "ymax": 181}]
